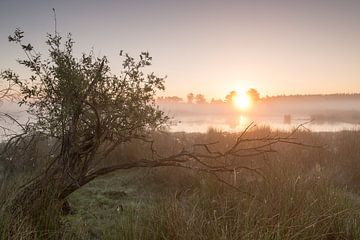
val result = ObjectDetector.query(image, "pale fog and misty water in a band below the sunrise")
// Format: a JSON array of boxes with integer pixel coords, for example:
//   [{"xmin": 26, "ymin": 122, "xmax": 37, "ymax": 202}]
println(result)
[{"xmin": 159, "ymin": 96, "xmax": 360, "ymax": 132}]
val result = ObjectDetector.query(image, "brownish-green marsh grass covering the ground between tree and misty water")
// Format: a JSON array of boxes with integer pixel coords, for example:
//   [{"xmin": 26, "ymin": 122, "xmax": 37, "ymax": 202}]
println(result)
[{"xmin": 0, "ymin": 128, "xmax": 360, "ymax": 240}]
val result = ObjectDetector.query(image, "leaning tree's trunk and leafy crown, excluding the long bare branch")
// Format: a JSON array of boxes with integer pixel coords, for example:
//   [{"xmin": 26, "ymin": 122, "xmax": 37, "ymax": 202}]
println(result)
[{"xmin": 1, "ymin": 29, "xmax": 167, "ymax": 227}]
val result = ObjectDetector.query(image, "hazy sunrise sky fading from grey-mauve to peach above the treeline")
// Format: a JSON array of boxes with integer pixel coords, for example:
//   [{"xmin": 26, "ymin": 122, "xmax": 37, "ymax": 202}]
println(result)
[{"xmin": 0, "ymin": 0, "xmax": 360, "ymax": 98}]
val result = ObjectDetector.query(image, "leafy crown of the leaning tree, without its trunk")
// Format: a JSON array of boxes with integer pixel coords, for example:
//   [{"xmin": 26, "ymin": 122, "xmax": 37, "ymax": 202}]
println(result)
[{"xmin": 1, "ymin": 29, "xmax": 166, "ymax": 142}]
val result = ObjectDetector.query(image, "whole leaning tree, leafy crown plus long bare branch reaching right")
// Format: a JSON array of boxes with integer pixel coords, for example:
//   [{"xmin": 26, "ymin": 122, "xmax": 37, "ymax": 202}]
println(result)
[{"xmin": 0, "ymin": 29, "xmax": 310, "ymax": 236}]
